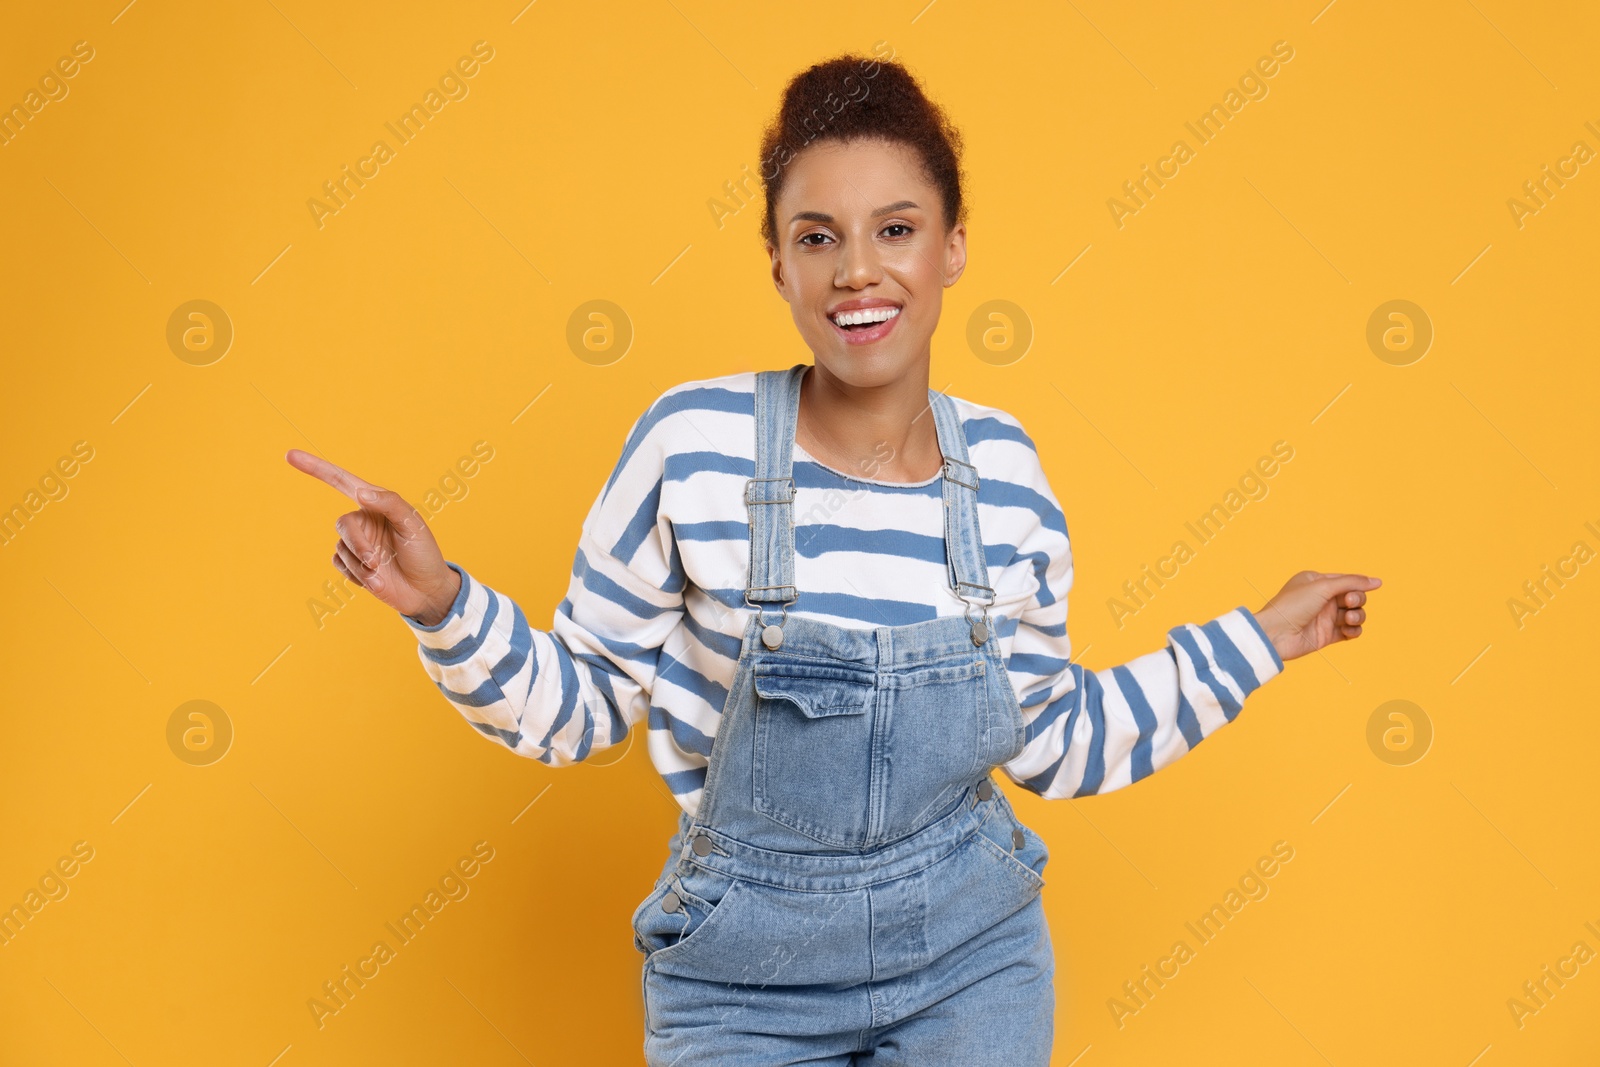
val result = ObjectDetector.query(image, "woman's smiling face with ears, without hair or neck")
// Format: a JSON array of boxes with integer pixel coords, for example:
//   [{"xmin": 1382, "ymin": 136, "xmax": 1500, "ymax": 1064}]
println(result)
[{"xmin": 766, "ymin": 139, "xmax": 966, "ymax": 387}]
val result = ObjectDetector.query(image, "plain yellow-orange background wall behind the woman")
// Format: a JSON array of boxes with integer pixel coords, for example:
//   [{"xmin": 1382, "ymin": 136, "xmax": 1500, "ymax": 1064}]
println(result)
[{"xmin": 0, "ymin": 0, "xmax": 1600, "ymax": 1067}]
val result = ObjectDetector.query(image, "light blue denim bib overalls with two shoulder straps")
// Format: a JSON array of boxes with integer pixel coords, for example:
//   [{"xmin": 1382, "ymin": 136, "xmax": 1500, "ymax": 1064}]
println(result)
[{"xmin": 634, "ymin": 365, "xmax": 1054, "ymax": 1067}]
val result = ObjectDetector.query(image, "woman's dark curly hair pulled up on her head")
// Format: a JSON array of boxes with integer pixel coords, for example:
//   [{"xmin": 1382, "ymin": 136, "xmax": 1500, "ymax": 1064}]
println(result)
[{"xmin": 762, "ymin": 54, "xmax": 966, "ymax": 245}]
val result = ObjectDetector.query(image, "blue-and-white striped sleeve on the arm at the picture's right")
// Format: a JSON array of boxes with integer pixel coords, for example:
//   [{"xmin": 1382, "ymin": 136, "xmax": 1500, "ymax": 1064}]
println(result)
[{"xmin": 1005, "ymin": 438, "xmax": 1283, "ymax": 800}]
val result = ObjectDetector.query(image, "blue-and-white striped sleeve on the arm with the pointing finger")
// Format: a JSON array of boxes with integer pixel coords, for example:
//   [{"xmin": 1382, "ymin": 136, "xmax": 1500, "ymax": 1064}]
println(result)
[{"xmin": 402, "ymin": 402, "xmax": 683, "ymax": 766}]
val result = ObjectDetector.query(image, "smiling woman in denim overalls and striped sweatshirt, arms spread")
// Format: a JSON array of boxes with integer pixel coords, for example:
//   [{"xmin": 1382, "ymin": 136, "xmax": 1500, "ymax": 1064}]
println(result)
[{"xmin": 288, "ymin": 56, "xmax": 1379, "ymax": 1067}]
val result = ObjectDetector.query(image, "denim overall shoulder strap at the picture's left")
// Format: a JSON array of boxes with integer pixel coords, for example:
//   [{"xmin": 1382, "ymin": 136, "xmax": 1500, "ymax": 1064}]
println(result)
[{"xmin": 744, "ymin": 363, "xmax": 806, "ymax": 605}]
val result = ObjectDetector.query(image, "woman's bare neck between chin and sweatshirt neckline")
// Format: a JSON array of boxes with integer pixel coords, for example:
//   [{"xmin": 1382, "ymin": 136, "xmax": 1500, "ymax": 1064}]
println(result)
[{"xmin": 795, "ymin": 362, "xmax": 944, "ymax": 482}]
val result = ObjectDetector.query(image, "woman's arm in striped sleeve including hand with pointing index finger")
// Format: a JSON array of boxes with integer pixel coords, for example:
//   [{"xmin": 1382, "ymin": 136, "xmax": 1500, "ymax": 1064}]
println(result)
[{"xmin": 288, "ymin": 399, "xmax": 685, "ymax": 766}]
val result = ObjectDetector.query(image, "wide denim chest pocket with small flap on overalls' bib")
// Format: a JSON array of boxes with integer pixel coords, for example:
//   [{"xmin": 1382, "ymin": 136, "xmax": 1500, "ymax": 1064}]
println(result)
[{"xmin": 752, "ymin": 656, "xmax": 987, "ymax": 848}]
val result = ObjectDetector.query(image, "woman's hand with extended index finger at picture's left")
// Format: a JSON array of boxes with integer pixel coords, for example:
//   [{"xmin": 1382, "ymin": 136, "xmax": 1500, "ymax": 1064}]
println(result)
[{"xmin": 285, "ymin": 448, "xmax": 461, "ymax": 625}]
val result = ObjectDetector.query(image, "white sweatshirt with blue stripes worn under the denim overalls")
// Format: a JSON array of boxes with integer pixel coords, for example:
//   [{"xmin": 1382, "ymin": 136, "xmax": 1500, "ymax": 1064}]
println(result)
[{"xmin": 402, "ymin": 371, "xmax": 1283, "ymax": 816}]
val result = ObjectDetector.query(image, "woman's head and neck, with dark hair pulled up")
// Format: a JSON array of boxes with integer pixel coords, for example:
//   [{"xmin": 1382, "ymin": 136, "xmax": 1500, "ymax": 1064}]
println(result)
[{"xmin": 762, "ymin": 56, "xmax": 966, "ymax": 482}]
